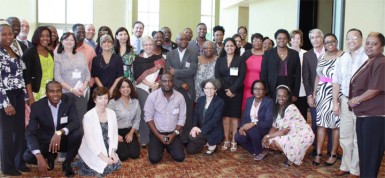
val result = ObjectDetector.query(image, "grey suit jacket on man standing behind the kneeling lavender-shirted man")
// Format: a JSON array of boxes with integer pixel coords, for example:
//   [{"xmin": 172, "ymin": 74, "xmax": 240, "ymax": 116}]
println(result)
[{"xmin": 166, "ymin": 48, "xmax": 198, "ymax": 101}]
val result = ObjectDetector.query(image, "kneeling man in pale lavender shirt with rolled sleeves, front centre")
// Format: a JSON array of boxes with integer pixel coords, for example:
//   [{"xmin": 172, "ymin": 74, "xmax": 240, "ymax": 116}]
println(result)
[{"xmin": 143, "ymin": 73, "xmax": 189, "ymax": 164}]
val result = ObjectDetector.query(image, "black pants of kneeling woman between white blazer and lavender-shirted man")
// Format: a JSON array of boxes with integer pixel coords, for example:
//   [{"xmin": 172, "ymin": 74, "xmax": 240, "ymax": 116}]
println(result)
[{"xmin": 116, "ymin": 128, "xmax": 140, "ymax": 161}]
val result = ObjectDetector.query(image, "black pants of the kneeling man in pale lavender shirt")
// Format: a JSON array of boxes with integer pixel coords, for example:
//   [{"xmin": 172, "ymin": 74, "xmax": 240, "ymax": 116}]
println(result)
[{"xmin": 148, "ymin": 132, "xmax": 185, "ymax": 164}]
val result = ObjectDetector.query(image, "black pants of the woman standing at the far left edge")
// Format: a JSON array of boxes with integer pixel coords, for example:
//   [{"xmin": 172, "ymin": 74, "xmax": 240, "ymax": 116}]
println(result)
[{"xmin": 0, "ymin": 89, "xmax": 26, "ymax": 173}]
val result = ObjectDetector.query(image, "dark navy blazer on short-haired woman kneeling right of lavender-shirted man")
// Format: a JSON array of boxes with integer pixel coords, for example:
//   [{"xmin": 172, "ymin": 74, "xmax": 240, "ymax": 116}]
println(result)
[{"xmin": 193, "ymin": 96, "xmax": 225, "ymax": 145}]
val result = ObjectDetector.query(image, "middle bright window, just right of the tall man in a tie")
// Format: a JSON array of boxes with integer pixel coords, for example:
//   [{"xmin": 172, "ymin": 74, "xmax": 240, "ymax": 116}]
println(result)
[{"xmin": 138, "ymin": 0, "xmax": 160, "ymax": 36}]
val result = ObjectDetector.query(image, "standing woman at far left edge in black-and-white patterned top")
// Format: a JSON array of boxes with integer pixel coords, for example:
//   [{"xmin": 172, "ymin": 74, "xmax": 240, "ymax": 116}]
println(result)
[{"xmin": 0, "ymin": 22, "xmax": 30, "ymax": 176}]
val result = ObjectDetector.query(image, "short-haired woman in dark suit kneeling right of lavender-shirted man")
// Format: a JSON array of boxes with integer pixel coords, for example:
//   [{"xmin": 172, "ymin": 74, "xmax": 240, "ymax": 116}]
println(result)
[{"xmin": 186, "ymin": 78, "xmax": 225, "ymax": 156}]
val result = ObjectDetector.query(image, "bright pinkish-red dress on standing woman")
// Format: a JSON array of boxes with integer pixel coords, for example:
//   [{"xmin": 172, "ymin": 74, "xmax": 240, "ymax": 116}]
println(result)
[{"xmin": 242, "ymin": 55, "xmax": 262, "ymax": 111}]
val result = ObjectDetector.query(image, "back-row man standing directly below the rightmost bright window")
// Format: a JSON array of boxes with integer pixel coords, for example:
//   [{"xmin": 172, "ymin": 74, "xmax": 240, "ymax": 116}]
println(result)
[{"xmin": 188, "ymin": 23, "xmax": 207, "ymax": 56}]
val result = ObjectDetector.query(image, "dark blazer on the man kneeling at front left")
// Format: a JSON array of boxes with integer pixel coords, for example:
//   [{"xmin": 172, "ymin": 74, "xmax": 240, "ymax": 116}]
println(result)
[{"xmin": 26, "ymin": 95, "xmax": 80, "ymax": 151}]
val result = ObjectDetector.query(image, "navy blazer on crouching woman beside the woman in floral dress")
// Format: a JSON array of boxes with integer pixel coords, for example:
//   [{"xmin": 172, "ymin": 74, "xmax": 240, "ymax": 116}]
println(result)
[{"xmin": 240, "ymin": 96, "xmax": 274, "ymax": 129}]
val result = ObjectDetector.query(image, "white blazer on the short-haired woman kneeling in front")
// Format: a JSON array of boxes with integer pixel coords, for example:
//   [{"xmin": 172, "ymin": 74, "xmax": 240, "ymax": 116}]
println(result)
[{"xmin": 79, "ymin": 108, "xmax": 118, "ymax": 173}]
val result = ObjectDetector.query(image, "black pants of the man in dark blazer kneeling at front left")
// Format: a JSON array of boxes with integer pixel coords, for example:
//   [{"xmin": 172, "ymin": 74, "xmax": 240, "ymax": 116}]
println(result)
[{"xmin": 24, "ymin": 129, "xmax": 83, "ymax": 165}]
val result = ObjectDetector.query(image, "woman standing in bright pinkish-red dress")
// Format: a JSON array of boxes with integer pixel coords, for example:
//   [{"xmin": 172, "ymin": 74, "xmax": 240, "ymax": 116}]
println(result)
[{"xmin": 242, "ymin": 33, "xmax": 264, "ymax": 111}]
